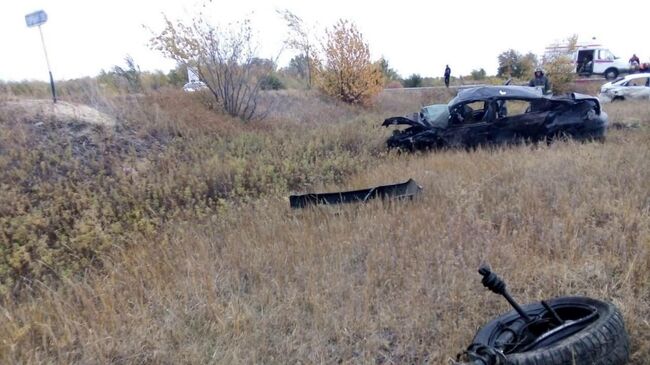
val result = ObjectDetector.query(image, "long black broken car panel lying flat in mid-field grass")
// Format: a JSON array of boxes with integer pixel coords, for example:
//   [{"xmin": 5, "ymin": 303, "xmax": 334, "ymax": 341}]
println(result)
[{"xmin": 289, "ymin": 179, "xmax": 422, "ymax": 208}]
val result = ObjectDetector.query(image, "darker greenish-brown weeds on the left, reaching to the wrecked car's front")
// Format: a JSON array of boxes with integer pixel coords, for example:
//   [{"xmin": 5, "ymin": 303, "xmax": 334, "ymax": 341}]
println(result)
[{"xmin": 0, "ymin": 92, "xmax": 385, "ymax": 296}]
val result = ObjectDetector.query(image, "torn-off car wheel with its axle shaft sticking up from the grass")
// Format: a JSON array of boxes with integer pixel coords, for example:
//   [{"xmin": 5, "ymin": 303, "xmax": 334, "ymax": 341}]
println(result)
[{"xmin": 450, "ymin": 266, "xmax": 629, "ymax": 365}]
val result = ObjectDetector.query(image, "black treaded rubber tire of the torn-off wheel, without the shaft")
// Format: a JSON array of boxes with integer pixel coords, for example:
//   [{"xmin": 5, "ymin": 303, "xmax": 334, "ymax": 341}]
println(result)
[{"xmin": 473, "ymin": 297, "xmax": 629, "ymax": 365}]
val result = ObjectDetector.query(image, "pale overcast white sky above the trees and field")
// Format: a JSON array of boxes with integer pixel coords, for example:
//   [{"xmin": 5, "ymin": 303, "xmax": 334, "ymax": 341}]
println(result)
[{"xmin": 0, "ymin": 0, "xmax": 650, "ymax": 80}]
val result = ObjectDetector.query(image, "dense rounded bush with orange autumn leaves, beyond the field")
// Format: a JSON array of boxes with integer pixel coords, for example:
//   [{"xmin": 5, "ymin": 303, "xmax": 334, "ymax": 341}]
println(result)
[{"xmin": 315, "ymin": 19, "xmax": 383, "ymax": 105}]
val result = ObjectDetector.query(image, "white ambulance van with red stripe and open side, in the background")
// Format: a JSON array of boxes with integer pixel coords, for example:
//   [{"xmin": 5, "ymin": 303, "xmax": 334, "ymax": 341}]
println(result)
[{"xmin": 572, "ymin": 45, "xmax": 630, "ymax": 80}]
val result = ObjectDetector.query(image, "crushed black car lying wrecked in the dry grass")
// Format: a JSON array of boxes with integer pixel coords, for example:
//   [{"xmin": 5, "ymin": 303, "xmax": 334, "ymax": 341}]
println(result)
[{"xmin": 382, "ymin": 86, "xmax": 608, "ymax": 151}]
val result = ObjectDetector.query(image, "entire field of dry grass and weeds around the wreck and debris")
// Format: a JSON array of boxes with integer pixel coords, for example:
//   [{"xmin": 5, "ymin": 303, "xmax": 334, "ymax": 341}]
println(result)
[{"xmin": 0, "ymin": 86, "xmax": 650, "ymax": 365}]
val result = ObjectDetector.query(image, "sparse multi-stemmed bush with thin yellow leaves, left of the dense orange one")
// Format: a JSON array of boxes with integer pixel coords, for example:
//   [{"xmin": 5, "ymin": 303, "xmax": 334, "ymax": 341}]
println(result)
[{"xmin": 151, "ymin": 18, "xmax": 275, "ymax": 120}]
